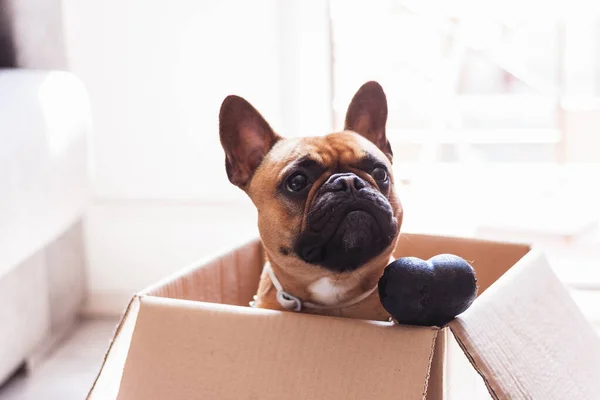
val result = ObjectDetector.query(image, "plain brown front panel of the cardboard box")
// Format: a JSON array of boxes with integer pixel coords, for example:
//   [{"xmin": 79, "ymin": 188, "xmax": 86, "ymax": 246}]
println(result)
[{"xmin": 118, "ymin": 296, "xmax": 438, "ymax": 400}]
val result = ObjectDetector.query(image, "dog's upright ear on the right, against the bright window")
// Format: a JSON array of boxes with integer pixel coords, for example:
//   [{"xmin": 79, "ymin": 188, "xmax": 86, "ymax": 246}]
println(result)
[{"xmin": 344, "ymin": 81, "xmax": 393, "ymax": 161}]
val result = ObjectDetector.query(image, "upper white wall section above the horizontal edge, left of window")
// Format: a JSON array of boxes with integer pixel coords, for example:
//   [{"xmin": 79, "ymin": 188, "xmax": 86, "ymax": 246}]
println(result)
[{"xmin": 65, "ymin": 0, "xmax": 281, "ymax": 199}]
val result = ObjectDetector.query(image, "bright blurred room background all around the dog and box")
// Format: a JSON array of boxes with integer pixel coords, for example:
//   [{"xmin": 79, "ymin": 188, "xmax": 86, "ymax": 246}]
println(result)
[{"xmin": 0, "ymin": 0, "xmax": 600, "ymax": 400}]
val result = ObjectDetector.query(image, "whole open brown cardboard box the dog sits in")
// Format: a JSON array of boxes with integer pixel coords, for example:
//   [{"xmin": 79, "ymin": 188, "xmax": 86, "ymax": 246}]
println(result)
[{"xmin": 88, "ymin": 234, "xmax": 600, "ymax": 400}]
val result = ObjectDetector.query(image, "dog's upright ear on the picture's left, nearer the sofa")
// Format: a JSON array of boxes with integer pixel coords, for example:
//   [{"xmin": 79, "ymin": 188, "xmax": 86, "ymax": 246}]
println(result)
[{"xmin": 219, "ymin": 95, "xmax": 280, "ymax": 190}]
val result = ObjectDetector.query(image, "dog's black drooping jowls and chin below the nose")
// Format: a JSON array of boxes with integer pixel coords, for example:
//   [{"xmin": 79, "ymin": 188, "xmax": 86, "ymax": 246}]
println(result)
[{"xmin": 296, "ymin": 210, "xmax": 397, "ymax": 272}]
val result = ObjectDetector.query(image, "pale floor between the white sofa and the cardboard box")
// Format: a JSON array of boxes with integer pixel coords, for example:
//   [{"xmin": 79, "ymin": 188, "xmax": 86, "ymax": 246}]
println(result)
[{"xmin": 0, "ymin": 319, "xmax": 118, "ymax": 400}]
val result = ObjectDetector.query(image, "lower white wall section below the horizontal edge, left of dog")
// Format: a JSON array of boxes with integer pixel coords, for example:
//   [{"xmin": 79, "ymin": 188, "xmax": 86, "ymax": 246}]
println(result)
[{"xmin": 86, "ymin": 200, "xmax": 257, "ymax": 314}]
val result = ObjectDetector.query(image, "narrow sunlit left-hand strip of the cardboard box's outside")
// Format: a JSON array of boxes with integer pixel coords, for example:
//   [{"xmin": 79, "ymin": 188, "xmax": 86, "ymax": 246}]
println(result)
[{"xmin": 86, "ymin": 296, "xmax": 140, "ymax": 400}]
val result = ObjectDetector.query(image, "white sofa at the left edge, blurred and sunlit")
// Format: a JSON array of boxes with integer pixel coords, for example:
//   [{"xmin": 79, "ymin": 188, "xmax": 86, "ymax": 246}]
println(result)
[{"xmin": 0, "ymin": 69, "xmax": 91, "ymax": 384}]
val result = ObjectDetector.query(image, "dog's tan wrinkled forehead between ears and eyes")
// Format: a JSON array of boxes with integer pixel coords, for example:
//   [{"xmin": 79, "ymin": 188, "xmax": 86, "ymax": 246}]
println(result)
[{"xmin": 266, "ymin": 132, "xmax": 391, "ymax": 174}]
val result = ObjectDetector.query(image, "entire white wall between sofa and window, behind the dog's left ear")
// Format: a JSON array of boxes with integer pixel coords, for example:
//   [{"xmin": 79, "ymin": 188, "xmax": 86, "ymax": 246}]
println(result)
[{"xmin": 64, "ymin": 0, "xmax": 331, "ymax": 312}]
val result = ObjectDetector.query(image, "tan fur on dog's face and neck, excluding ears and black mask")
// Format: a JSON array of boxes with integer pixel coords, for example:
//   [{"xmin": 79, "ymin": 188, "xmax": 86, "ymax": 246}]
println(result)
[{"xmin": 247, "ymin": 131, "xmax": 403, "ymax": 320}]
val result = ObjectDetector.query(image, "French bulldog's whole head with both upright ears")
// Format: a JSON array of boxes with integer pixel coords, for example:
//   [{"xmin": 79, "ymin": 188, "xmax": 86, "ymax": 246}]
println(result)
[{"xmin": 219, "ymin": 82, "xmax": 402, "ymax": 273}]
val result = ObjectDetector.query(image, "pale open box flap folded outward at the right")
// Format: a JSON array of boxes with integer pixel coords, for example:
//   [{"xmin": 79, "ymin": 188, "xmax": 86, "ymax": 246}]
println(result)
[{"xmin": 450, "ymin": 251, "xmax": 600, "ymax": 400}]
